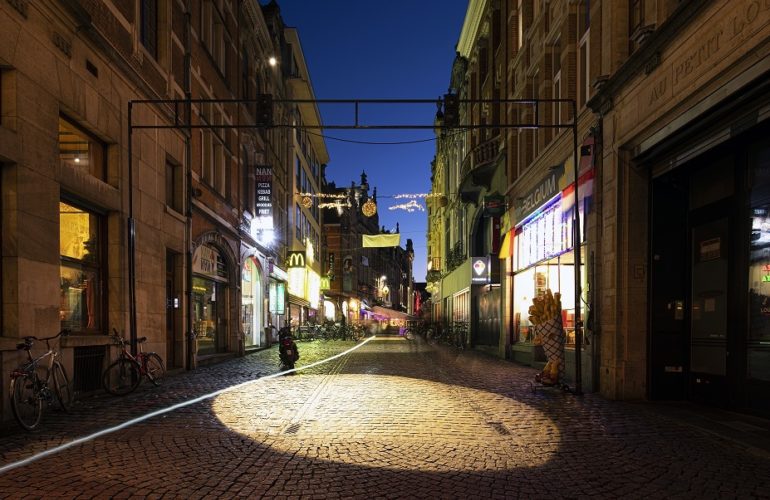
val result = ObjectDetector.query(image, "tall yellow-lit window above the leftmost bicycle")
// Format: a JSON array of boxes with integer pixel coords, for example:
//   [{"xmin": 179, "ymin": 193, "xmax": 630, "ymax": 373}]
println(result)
[{"xmin": 59, "ymin": 202, "xmax": 104, "ymax": 333}]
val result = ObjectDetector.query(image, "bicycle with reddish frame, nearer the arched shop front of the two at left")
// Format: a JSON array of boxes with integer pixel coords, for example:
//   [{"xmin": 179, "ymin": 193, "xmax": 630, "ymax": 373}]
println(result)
[{"xmin": 102, "ymin": 328, "xmax": 166, "ymax": 396}]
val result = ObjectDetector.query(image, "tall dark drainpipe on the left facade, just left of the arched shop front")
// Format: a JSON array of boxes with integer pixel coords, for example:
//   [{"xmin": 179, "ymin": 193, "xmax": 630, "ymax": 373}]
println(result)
[{"xmin": 182, "ymin": 0, "xmax": 195, "ymax": 370}]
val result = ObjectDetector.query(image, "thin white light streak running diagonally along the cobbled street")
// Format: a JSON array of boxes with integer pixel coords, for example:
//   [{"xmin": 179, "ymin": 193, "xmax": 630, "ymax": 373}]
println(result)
[{"xmin": 0, "ymin": 335, "xmax": 376, "ymax": 474}]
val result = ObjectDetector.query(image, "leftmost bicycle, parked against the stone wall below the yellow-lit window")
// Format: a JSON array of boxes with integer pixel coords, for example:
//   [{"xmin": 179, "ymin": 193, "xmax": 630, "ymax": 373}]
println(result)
[{"xmin": 9, "ymin": 330, "xmax": 74, "ymax": 431}]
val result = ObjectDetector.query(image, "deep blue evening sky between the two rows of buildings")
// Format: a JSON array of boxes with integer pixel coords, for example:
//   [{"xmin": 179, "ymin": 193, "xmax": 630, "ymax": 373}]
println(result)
[{"xmin": 272, "ymin": 0, "xmax": 468, "ymax": 281}]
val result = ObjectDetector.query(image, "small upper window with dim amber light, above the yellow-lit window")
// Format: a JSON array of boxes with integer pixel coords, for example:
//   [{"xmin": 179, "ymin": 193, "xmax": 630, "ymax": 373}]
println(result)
[{"xmin": 59, "ymin": 117, "xmax": 107, "ymax": 180}]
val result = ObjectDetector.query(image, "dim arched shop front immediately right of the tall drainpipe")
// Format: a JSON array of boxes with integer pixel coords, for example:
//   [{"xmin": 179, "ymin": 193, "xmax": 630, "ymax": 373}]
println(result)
[{"xmin": 192, "ymin": 244, "xmax": 230, "ymax": 355}]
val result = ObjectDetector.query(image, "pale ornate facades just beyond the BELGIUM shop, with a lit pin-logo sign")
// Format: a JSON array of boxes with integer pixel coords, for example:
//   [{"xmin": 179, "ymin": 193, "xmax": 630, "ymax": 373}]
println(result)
[{"xmin": 428, "ymin": 2, "xmax": 508, "ymax": 352}]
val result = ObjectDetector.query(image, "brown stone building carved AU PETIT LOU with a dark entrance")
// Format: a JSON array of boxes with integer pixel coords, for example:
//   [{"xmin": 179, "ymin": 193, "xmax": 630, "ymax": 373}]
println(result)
[{"xmin": 589, "ymin": 0, "xmax": 770, "ymax": 415}]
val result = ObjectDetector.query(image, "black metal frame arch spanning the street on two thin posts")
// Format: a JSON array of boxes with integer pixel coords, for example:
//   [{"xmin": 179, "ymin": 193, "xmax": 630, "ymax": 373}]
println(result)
[{"xmin": 128, "ymin": 93, "xmax": 583, "ymax": 394}]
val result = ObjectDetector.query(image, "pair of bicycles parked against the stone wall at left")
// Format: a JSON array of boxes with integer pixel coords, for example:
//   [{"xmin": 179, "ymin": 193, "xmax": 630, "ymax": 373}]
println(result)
[{"xmin": 10, "ymin": 329, "xmax": 166, "ymax": 431}]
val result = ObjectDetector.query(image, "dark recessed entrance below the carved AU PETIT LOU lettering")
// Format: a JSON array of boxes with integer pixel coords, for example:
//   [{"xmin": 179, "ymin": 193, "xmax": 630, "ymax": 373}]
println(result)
[{"xmin": 648, "ymin": 127, "xmax": 770, "ymax": 414}]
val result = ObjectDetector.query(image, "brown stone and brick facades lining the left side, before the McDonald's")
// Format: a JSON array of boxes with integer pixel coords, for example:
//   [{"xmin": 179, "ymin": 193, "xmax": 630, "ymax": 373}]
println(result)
[{"xmin": 0, "ymin": 0, "xmax": 306, "ymax": 418}]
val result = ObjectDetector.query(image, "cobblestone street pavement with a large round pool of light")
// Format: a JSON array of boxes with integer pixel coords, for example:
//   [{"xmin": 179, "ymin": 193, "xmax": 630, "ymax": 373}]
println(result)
[{"xmin": 0, "ymin": 338, "xmax": 770, "ymax": 499}]
